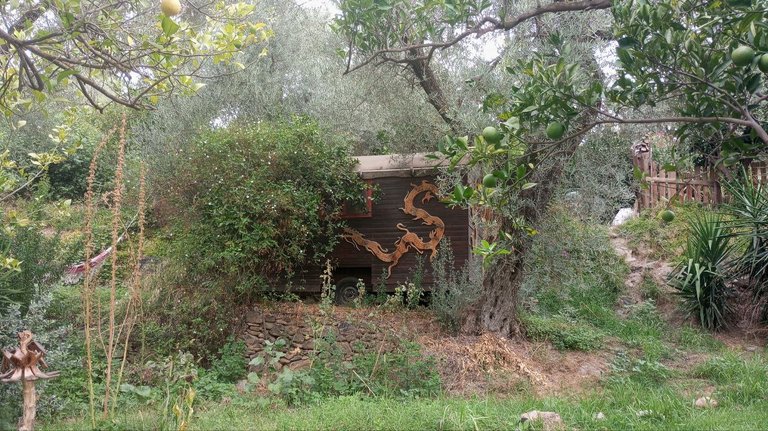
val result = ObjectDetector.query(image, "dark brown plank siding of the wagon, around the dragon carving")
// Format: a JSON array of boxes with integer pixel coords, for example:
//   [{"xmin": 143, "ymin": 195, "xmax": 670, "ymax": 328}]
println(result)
[{"xmin": 293, "ymin": 176, "xmax": 470, "ymax": 292}]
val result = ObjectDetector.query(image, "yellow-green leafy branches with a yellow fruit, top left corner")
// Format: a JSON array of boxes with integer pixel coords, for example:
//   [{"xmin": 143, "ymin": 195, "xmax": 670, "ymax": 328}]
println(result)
[{"xmin": 0, "ymin": 0, "xmax": 271, "ymax": 116}]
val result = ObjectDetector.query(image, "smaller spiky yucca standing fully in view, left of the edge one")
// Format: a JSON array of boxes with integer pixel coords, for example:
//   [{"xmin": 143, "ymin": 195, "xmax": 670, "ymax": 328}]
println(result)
[{"xmin": 669, "ymin": 214, "xmax": 733, "ymax": 330}]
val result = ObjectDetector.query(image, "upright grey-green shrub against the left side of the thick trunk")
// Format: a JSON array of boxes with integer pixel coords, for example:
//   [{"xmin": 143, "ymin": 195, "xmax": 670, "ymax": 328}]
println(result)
[{"xmin": 429, "ymin": 238, "xmax": 482, "ymax": 333}]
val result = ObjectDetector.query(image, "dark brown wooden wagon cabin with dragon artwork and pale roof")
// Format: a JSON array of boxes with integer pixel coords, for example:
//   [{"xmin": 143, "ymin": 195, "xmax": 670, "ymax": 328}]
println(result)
[{"xmin": 293, "ymin": 154, "xmax": 470, "ymax": 303}]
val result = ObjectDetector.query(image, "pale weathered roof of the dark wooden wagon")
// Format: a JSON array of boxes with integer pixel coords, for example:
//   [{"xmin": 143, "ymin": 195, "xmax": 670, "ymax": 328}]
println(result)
[{"xmin": 355, "ymin": 153, "xmax": 447, "ymax": 179}]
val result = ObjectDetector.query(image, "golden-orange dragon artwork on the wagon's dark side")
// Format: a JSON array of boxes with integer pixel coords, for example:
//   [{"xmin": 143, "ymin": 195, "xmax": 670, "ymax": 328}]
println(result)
[{"xmin": 341, "ymin": 180, "xmax": 445, "ymax": 278}]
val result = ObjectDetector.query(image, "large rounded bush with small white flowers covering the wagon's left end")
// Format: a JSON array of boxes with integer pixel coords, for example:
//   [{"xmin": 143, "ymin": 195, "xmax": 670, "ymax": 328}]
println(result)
[{"xmin": 164, "ymin": 118, "xmax": 364, "ymax": 292}]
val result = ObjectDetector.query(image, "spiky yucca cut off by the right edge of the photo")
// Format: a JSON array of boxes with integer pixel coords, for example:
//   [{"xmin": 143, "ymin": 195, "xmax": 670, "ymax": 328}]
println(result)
[{"xmin": 724, "ymin": 172, "xmax": 768, "ymax": 308}]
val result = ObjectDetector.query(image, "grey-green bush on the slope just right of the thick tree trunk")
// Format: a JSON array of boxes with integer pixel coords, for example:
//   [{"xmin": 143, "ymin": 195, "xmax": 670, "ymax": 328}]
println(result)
[{"xmin": 521, "ymin": 206, "xmax": 628, "ymax": 350}]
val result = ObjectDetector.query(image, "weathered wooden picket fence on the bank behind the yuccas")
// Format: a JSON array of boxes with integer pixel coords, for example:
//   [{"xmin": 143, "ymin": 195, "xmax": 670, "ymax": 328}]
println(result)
[{"xmin": 633, "ymin": 152, "xmax": 768, "ymax": 210}]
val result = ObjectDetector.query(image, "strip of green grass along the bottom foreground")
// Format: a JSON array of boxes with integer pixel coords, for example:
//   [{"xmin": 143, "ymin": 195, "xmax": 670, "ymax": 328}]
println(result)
[{"xmin": 40, "ymin": 382, "xmax": 768, "ymax": 430}]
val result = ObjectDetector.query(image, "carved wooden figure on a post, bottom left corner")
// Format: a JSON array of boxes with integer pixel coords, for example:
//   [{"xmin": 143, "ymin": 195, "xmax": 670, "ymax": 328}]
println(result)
[{"xmin": 0, "ymin": 331, "xmax": 59, "ymax": 431}]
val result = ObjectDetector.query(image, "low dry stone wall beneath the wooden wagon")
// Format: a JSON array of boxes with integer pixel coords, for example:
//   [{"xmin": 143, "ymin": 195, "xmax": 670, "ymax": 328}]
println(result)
[{"xmin": 243, "ymin": 304, "xmax": 410, "ymax": 369}]
